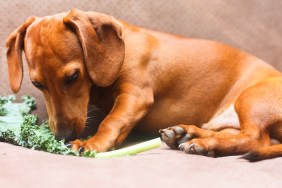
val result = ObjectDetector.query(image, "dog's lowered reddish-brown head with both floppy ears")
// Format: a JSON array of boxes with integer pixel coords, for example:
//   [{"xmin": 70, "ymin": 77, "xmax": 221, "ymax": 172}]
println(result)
[{"xmin": 6, "ymin": 10, "xmax": 125, "ymax": 139}]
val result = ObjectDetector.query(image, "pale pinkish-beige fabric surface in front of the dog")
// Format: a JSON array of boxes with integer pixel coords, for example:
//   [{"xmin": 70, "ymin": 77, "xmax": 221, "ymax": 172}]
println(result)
[{"xmin": 0, "ymin": 143, "xmax": 282, "ymax": 188}]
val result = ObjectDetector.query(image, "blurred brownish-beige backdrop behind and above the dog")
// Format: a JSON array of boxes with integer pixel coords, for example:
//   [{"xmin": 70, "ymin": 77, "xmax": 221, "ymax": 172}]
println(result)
[{"xmin": 0, "ymin": 0, "xmax": 282, "ymax": 119}]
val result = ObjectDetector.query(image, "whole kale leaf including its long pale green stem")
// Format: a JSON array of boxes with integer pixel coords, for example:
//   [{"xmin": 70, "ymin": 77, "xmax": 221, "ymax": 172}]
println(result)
[{"xmin": 0, "ymin": 96, "xmax": 161, "ymax": 158}]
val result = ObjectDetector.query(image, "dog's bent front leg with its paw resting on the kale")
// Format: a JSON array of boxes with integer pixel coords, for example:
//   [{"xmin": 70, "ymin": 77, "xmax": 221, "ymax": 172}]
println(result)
[{"xmin": 72, "ymin": 89, "xmax": 151, "ymax": 152}]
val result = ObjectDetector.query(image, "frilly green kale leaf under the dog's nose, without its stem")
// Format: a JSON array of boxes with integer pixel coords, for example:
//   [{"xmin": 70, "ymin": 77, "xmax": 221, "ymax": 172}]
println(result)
[{"xmin": 0, "ymin": 96, "xmax": 78, "ymax": 155}]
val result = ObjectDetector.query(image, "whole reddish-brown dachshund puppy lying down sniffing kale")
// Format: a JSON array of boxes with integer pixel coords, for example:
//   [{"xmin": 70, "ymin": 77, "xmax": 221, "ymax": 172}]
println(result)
[{"xmin": 6, "ymin": 10, "xmax": 282, "ymax": 160}]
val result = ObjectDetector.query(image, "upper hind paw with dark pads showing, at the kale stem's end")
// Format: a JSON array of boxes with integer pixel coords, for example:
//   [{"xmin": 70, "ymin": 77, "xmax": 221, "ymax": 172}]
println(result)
[{"xmin": 159, "ymin": 126, "xmax": 192, "ymax": 149}]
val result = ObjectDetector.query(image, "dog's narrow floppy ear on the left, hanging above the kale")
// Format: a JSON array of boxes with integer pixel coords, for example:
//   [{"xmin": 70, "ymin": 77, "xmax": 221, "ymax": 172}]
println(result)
[{"xmin": 6, "ymin": 17, "xmax": 35, "ymax": 93}]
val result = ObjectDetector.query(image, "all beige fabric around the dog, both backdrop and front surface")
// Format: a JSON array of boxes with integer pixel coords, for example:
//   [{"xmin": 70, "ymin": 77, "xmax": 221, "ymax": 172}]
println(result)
[{"xmin": 0, "ymin": 0, "xmax": 282, "ymax": 188}]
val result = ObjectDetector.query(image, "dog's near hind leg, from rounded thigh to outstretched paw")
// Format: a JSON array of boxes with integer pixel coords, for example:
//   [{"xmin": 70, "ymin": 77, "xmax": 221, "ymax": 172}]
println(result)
[{"xmin": 163, "ymin": 79, "xmax": 282, "ymax": 158}]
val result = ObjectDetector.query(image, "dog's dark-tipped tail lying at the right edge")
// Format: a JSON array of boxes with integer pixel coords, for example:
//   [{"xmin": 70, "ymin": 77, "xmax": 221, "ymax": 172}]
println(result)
[{"xmin": 242, "ymin": 144, "xmax": 282, "ymax": 162}]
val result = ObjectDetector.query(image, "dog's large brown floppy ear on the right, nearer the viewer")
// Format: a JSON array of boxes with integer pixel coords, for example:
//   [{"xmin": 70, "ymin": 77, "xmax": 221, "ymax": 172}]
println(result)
[{"xmin": 64, "ymin": 9, "xmax": 125, "ymax": 87}]
